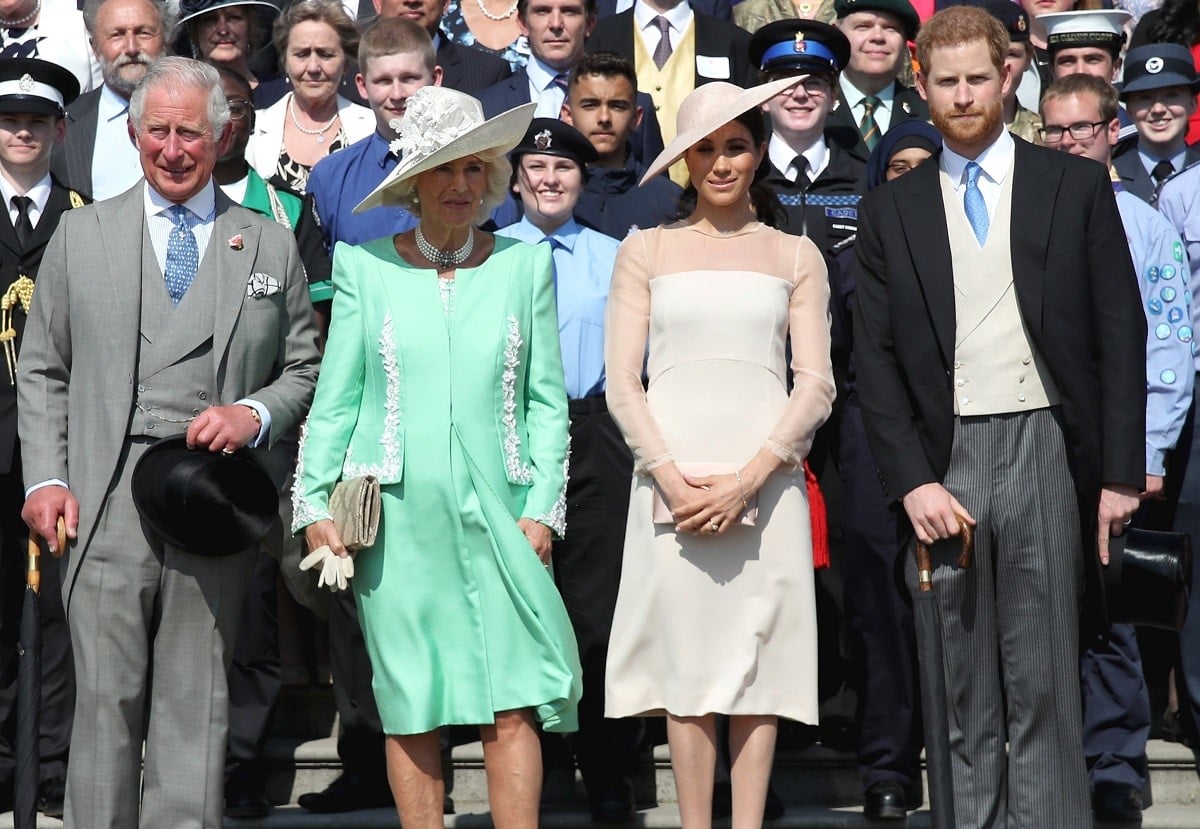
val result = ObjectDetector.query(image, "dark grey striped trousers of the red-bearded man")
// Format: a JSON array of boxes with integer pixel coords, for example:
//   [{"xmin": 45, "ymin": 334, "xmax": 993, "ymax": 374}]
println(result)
[{"xmin": 906, "ymin": 408, "xmax": 1092, "ymax": 829}]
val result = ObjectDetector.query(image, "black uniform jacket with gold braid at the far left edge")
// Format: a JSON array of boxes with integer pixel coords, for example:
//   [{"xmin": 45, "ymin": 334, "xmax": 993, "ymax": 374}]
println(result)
[{"xmin": 0, "ymin": 176, "xmax": 88, "ymax": 474}]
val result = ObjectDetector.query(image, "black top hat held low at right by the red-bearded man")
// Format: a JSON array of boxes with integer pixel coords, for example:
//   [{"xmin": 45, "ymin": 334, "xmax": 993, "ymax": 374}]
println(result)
[{"xmin": 1104, "ymin": 529, "xmax": 1192, "ymax": 630}]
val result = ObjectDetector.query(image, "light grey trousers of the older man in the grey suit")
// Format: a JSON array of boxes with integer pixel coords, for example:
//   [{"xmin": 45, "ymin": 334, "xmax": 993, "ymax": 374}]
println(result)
[{"xmin": 64, "ymin": 438, "xmax": 254, "ymax": 829}]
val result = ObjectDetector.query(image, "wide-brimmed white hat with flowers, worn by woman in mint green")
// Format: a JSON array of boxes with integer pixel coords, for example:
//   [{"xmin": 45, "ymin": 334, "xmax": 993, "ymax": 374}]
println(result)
[{"xmin": 354, "ymin": 86, "xmax": 538, "ymax": 214}]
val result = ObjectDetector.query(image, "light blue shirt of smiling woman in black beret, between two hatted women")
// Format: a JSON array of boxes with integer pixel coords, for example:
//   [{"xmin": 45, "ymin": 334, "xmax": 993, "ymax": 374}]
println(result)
[{"xmin": 496, "ymin": 216, "xmax": 620, "ymax": 400}]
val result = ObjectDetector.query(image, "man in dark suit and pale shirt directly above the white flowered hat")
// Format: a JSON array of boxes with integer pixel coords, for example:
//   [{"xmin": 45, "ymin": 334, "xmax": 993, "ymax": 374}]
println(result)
[{"xmin": 475, "ymin": 0, "xmax": 664, "ymax": 164}]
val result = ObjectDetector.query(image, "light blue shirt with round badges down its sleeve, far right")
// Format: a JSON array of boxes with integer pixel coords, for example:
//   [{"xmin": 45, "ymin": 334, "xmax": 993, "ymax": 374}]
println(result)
[{"xmin": 1117, "ymin": 190, "xmax": 1195, "ymax": 475}]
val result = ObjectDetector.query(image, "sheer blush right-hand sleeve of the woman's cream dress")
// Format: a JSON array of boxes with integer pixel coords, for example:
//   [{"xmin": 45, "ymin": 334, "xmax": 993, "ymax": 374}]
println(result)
[{"xmin": 763, "ymin": 238, "xmax": 835, "ymax": 465}]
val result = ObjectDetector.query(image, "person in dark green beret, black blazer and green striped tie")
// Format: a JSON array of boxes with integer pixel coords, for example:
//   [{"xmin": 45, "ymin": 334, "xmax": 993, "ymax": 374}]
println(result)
[{"xmin": 828, "ymin": 0, "xmax": 929, "ymax": 161}]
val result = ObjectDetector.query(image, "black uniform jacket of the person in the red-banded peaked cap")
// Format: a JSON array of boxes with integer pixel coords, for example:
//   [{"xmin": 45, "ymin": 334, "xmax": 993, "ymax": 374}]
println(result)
[{"xmin": 763, "ymin": 133, "xmax": 866, "ymax": 259}]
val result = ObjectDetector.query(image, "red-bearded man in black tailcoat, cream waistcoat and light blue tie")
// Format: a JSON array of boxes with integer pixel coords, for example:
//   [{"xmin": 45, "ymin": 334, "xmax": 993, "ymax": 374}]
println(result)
[{"xmin": 854, "ymin": 6, "xmax": 1146, "ymax": 829}]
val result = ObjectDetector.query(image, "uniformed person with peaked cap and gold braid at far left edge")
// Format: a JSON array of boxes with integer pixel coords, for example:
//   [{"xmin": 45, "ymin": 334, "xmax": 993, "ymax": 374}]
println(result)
[{"xmin": 0, "ymin": 59, "xmax": 84, "ymax": 817}]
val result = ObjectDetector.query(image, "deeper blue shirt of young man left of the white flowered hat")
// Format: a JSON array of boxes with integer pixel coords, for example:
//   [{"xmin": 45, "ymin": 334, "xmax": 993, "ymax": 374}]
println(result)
[{"xmin": 308, "ymin": 132, "xmax": 416, "ymax": 245}]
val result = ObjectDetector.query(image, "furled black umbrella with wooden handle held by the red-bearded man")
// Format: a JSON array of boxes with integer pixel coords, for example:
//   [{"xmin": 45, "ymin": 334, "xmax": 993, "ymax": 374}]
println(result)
[{"xmin": 912, "ymin": 519, "xmax": 973, "ymax": 829}]
